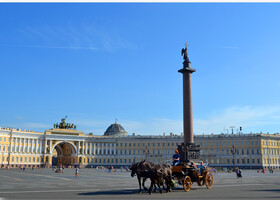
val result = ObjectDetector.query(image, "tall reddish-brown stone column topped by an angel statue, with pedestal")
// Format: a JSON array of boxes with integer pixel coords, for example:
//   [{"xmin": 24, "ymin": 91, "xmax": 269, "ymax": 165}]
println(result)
[{"xmin": 178, "ymin": 43, "xmax": 200, "ymax": 163}]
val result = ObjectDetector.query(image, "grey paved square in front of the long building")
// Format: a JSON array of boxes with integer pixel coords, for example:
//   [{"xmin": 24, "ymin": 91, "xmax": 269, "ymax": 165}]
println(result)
[{"xmin": 0, "ymin": 169, "xmax": 280, "ymax": 200}]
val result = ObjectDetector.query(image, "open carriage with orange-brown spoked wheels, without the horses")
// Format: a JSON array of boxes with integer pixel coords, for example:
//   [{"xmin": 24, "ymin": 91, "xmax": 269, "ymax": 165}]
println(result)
[{"xmin": 172, "ymin": 162, "xmax": 213, "ymax": 192}]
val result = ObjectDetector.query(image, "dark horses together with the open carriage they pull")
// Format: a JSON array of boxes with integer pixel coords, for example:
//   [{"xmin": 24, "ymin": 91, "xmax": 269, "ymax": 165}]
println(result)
[{"xmin": 130, "ymin": 160, "xmax": 213, "ymax": 194}]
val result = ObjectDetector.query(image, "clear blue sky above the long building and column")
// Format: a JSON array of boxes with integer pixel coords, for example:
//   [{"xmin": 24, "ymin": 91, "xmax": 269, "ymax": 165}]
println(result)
[{"xmin": 0, "ymin": 3, "xmax": 280, "ymax": 135}]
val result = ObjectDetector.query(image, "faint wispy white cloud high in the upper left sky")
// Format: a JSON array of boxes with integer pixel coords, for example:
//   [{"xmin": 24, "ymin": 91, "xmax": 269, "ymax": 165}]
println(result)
[{"xmin": 14, "ymin": 22, "xmax": 136, "ymax": 51}]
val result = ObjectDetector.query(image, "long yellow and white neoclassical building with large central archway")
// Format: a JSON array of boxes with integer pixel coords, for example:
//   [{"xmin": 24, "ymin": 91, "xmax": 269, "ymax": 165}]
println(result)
[{"xmin": 0, "ymin": 118, "xmax": 280, "ymax": 169}]
